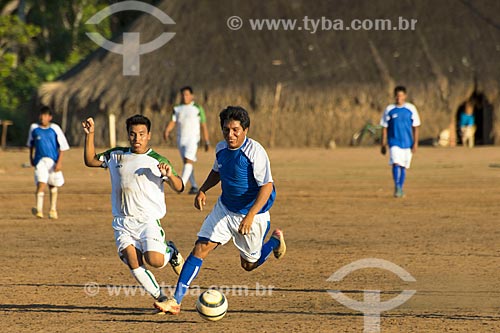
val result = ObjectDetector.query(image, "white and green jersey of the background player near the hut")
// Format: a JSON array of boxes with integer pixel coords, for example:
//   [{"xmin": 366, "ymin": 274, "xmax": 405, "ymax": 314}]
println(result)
[{"xmin": 172, "ymin": 102, "xmax": 207, "ymax": 145}]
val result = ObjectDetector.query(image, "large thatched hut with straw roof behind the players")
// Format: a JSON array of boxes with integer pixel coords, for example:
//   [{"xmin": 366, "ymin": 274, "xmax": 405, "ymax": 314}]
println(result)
[{"xmin": 39, "ymin": 0, "xmax": 500, "ymax": 147}]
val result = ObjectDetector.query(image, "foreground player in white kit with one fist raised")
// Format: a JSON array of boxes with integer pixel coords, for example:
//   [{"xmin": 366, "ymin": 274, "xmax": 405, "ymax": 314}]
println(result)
[{"xmin": 82, "ymin": 115, "xmax": 184, "ymax": 308}]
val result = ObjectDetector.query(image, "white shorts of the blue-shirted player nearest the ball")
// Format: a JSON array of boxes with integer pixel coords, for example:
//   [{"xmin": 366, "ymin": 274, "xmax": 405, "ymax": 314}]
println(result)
[{"xmin": 198, "ymin": 198, "xmax": 271, "ymax": 262}]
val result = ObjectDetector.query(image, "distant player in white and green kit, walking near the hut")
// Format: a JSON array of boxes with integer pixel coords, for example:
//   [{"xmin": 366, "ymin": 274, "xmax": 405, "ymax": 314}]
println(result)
[{"xmin": 164, "ymin": 86, "xmax": 210, "ymax": 194}]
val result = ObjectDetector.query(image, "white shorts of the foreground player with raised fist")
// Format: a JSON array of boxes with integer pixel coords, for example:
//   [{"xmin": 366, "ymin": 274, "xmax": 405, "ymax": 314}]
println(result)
[{"xmin": 113, "ymin": 217, "xmax": 167, "ymax": 257}]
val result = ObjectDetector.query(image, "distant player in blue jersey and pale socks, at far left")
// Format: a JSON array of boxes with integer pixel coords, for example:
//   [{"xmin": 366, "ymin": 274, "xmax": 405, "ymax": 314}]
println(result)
[{"xmin": 27, "ymin": 106, "xmax": 69, "ymax": 219}]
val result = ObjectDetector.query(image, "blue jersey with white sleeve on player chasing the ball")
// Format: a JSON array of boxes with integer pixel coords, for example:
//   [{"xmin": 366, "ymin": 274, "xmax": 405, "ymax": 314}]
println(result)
[{"xmin": 213, "ymin": 138, "xmax": 276, "ymax": 215}]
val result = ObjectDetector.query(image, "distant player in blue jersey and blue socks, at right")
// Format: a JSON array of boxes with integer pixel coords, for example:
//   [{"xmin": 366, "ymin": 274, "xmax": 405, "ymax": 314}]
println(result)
[{"xmin": 380, "ymin": 86, "xmax": 420, "ymax": 198}]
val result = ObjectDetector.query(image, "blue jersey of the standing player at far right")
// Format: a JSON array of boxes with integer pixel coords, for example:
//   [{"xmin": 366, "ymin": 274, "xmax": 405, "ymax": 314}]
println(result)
[{"xmin": 380, "ymin": 103, "xmax": 420, "ymax": 149}]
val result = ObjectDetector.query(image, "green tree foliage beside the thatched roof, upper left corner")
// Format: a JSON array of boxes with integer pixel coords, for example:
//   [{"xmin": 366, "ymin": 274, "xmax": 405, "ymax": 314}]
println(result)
[{"xmin": 0, "ymin": 0, "xmax": 113, "ymax": 145}]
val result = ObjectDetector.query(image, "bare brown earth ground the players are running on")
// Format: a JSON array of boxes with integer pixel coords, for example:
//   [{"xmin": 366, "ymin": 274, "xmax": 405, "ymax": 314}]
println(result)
[{"xmin": 0, "ymin": 148, "xmax": 500, "ymax": 333}]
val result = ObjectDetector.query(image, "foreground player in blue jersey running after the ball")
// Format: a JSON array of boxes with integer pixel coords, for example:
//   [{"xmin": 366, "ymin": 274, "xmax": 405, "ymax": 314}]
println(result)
[{"xmin": 155, "ymin": 106, "xmax": 286, "ymax": 314}]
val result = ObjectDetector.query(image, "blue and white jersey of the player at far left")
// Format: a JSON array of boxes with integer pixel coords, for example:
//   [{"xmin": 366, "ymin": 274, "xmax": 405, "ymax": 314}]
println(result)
[{"xmin": 27, "ymin": 123, "xmax": 69, "ymax": 165}]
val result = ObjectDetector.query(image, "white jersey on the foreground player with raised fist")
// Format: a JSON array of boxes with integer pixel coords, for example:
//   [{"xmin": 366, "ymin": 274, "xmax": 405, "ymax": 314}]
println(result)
[{"xmin": 97, "ymin": 147, "xmax": 177, "ymax": 222}]
